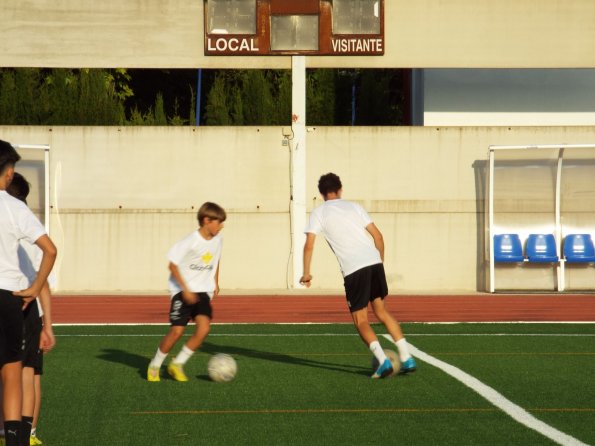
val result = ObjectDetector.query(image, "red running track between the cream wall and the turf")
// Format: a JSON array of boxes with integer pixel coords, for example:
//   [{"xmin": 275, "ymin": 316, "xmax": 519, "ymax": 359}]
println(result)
[{"xmin": 52, "ymin": 294, "xmax": 595, "ymax": 324}]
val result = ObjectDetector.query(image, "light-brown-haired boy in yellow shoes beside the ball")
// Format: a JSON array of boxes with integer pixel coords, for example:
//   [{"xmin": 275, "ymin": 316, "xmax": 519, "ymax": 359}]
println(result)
[{"xmin": 147, "ymin": 202, "xmax": 227, "ymax": 382}]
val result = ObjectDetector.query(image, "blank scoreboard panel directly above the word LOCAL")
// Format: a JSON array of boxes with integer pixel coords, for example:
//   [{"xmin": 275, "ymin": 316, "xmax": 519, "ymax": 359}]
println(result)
[{"xmin": 207, "ymin": 0, "xmax": 256, "ymax": 34}]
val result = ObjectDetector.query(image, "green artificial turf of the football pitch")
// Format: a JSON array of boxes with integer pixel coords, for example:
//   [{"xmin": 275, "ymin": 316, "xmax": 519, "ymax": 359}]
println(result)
[{"xmin": 38, "ymin": 324, "xmax": 595, "ymax": 446}]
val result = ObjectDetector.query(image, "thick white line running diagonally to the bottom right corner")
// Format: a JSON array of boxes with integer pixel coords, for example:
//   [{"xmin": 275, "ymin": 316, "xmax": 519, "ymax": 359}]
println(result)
[{"xmin": 383, "ymin": 334, "xmax": 587, "ymax": 446}]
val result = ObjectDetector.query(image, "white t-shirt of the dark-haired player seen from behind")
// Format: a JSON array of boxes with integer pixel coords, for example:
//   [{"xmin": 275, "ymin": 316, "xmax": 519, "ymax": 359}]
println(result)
[{"xmin": 305, "ymin": 199, "xmax": 382, "ymax": 276}]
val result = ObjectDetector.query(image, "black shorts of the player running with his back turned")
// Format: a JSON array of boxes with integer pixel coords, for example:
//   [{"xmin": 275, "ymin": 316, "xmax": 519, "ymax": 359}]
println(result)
[{"xmin": 344, "ymin": 263, "xmax": 388, "ymax": 313}]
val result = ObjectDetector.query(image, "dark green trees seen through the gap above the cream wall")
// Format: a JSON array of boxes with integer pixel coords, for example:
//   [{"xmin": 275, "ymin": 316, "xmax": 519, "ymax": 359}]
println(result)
[{"xmin": 0, "ymin": 68, "xmax": 405, "ymax": 125}]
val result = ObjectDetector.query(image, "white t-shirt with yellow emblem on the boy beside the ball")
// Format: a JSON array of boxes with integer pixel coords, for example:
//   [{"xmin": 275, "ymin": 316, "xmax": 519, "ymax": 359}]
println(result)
[{"xmin": 167, "ymin": 231, "xmax": 223, "ymax": 297}]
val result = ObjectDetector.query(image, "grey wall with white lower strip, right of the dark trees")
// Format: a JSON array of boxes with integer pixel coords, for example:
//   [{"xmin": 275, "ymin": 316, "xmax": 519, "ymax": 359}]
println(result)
[{"xmin": 423, "ymin": 69, "xmax": 595, "ymax": 126}]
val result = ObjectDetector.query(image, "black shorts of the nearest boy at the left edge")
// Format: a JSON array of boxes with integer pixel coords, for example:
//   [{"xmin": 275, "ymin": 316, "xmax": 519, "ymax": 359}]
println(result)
[{"xmin": 0, "ymin": 290, "xmax": 23, "ymax": 367}]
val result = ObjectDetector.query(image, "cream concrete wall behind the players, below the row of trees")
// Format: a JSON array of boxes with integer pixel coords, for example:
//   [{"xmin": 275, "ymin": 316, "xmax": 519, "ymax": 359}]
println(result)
[{"xmin": 0, "ymin": 126, "xmax": 595, "ymax": 293}]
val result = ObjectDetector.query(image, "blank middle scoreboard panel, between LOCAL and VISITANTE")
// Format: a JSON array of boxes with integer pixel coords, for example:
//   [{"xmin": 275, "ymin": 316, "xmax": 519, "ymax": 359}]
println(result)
[{"xmin": 271, "ymin": 15, "xmax": 318, "ymax": 51}]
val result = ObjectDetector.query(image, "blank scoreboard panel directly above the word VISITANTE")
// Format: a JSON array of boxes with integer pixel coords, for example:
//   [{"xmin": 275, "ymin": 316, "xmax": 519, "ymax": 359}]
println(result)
[{"xmin": 333, "ymin": 0, "xmax": 380, "ymax": 34}]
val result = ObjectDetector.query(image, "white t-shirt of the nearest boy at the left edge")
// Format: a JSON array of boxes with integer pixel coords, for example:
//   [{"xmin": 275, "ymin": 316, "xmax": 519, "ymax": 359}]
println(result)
[{"xmin": 0, "ymin": 190, "xmax": 46, "ymax": 291}]
